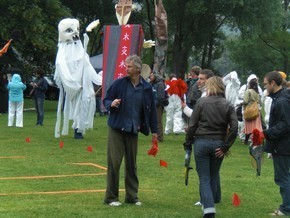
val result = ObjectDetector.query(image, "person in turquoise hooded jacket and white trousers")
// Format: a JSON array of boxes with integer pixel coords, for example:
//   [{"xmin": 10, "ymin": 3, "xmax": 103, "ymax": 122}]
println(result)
[{"xmin": 7, "ymin": 74, "xmax": 26, "ymax": 127}]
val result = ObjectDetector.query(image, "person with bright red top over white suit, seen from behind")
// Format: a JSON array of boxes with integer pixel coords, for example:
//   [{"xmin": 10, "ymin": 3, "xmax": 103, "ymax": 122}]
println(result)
[{"xmin": 164, "ymin": 73, "xmax": 187, "ymax": 134}]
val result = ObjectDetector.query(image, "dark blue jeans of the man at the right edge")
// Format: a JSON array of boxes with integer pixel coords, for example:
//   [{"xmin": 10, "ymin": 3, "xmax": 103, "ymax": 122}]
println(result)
[{"xmin": 273, "ymin": 154, "xmax": 290, "ymax": 216}]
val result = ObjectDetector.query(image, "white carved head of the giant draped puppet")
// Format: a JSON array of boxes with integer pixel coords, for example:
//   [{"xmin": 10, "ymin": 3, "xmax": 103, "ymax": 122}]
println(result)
[{"xmin": 58, "ymin": 18, "xmax": 80, "ymax": 43}]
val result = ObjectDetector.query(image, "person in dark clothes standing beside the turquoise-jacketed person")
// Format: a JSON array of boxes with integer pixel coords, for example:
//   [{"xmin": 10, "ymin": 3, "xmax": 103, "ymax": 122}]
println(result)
[{"xmin": 31, "ymin": 69, "xmax": 48, "ymax": 126}]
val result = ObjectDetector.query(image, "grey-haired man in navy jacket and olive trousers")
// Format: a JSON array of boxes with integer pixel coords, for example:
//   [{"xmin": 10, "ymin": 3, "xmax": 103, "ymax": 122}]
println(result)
[{"xmin": 103, "ymin": 55, "xmax": 157, "ymax": 206}]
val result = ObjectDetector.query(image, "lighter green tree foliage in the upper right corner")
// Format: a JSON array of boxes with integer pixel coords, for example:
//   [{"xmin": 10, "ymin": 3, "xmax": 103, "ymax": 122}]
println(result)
[{"xmin": 228, "ymin": 0, "xmax": 290, "ymax": 76}]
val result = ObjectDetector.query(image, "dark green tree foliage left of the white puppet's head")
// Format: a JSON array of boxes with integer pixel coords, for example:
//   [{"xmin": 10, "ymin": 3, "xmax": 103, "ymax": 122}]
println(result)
[{"xmin": 0, "ymin": 0, "xmax": 70, "ymax": 71}]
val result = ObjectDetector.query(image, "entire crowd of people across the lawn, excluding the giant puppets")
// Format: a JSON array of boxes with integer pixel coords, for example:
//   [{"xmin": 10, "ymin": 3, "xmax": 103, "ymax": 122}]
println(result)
[{"xmin": 0, "ymin": 60, "xmax": 290, "ymax": 217}]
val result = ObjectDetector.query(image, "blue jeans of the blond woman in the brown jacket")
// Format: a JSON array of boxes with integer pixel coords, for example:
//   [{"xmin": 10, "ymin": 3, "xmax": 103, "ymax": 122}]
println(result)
[{"xmin": 194, "ymin": 139, "xmax": 224, "ymax": 214}]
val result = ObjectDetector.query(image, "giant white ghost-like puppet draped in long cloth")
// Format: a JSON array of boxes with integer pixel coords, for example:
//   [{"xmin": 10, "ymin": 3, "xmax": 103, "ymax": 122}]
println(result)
[{"xmin": 54, "ymin": 18, "xmax": 102, "ymax": 138}]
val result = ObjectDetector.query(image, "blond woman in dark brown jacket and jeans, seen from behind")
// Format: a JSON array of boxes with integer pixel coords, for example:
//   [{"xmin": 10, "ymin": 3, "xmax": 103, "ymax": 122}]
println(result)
[{"xmin": 184, "ymin": 76, "xmax": 238, "ymax": 217}]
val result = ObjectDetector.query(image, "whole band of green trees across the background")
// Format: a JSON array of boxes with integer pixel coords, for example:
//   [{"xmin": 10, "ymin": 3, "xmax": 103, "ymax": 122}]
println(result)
[{"xmin": 0, "ymin": 0, "xmax": 290, "ymax": 77}]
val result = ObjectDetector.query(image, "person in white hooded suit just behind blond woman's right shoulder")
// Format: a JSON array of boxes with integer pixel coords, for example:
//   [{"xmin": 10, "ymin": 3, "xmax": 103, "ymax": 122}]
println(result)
[{"xmin": 223, "ymin": 71, "xmax": 241, "ymax": 106}]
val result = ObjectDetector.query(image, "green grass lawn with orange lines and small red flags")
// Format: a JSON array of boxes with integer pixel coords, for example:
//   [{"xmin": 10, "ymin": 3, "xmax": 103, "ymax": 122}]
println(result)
[{"xmin": 0, "ymin": 99, "xmax": 281, "ymax": 218}]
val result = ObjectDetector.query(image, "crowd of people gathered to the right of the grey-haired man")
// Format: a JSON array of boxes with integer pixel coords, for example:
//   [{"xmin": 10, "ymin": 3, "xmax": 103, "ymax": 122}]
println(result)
[{"xmin": 144, "ymin": 66, "xmax": 290, "ymax": 217}]
